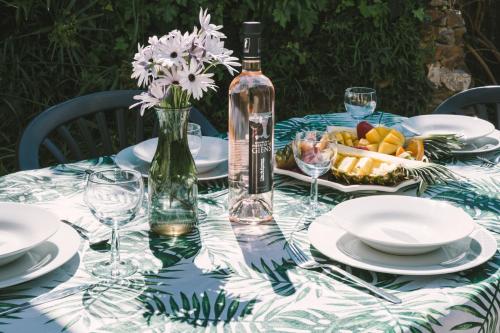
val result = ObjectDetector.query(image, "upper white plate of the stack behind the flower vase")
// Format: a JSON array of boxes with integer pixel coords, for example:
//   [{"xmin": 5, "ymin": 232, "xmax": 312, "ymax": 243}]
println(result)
[{"xmin": 133, "ymin": 136, "xmax": 228, "ymax": 173}]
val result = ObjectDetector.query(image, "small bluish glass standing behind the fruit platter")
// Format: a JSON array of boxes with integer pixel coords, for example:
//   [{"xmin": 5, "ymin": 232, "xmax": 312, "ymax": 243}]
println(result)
[{"xmin": 344, "ymin": 87, "xmax": 377, "ymax": 121}]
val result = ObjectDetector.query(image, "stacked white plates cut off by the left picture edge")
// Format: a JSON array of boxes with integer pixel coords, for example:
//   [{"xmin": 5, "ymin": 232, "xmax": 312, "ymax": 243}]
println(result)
[{"xmin": 0, "ymin": 203, "xmax": 80, "ymax": 288}]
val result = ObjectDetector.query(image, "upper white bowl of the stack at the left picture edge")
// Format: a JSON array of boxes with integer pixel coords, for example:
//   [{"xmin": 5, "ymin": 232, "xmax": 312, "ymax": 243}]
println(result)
[{"xmin": 0, "ymin": 202, "xmax": 59, "ymax": 265}]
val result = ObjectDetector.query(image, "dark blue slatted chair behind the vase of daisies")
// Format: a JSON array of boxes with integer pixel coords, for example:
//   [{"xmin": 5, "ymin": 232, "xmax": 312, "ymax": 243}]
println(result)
[{"xmin": 18, "ymin": 90, "xmax": 219, "ymax": 170}]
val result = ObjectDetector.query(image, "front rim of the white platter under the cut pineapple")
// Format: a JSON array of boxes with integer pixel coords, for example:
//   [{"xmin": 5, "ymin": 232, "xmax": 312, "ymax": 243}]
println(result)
[{"xmin": 274, "ymin": 167, "xmax": 419, "ymax": 193}]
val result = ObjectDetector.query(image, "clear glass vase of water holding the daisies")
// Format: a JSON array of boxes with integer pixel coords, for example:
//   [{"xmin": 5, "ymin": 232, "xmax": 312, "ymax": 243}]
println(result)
[{"xmin": 148, "ymin": 107, "xmax": 198, "ymax": 236}]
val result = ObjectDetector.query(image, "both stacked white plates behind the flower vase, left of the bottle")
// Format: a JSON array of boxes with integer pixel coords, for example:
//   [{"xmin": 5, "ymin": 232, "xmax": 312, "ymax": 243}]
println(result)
[{"xmin": 115, "ymin": 136, "xmax": 228, "ymax": 180}]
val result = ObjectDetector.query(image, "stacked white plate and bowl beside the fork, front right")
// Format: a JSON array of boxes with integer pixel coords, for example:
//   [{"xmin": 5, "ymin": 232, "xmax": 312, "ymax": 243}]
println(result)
[{"xmin": 309, "ymin": 195, "xmax": 497, "ymax": 275}]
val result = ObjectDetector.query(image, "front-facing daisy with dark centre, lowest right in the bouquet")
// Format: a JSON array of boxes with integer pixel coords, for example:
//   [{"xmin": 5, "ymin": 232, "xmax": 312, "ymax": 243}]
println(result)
[{"xmin": 179, "ymin": 59, "xmax": 217, "ymax": 99}]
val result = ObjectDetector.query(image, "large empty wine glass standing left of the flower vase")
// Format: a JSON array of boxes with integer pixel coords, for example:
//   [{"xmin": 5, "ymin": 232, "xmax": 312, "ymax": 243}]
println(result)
[{"xmin": 84, "ymin": 169, "xmax": 144, "ymax": 279}]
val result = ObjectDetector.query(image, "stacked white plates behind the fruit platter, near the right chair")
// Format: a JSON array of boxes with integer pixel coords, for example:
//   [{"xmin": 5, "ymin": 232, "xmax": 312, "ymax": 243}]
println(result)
[{"xmin": 402, "ymin": 114, "xmax": 500, "ymax": 154}]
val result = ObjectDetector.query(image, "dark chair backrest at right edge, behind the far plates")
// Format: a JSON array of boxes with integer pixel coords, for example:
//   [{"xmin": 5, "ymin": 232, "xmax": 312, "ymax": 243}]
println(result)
[{"xmin": 433, "ymin": 86, "xmax": 500, "ymax": 129}]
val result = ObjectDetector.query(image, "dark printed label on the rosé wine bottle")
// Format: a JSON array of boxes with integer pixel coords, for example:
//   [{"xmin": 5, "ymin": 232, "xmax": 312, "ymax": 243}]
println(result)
[{"xmin": 248, "ymin": 112, "xmax": 273, "ymax": 194}]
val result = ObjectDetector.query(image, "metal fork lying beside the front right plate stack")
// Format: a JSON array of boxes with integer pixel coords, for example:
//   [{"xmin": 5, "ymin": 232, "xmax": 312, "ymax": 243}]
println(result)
[{"xmin": 287, "ymin": 241, "xmax": 402, "ymax": 304}]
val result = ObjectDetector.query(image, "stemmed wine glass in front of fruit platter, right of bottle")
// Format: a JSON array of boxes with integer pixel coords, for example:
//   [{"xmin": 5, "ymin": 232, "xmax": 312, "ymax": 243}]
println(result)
[{"xmin": 292, "ymin": 131, "xmax": 337, "ymax": 215}]
